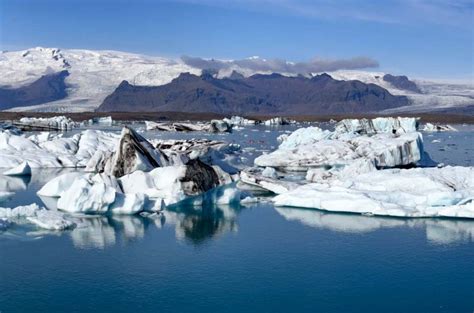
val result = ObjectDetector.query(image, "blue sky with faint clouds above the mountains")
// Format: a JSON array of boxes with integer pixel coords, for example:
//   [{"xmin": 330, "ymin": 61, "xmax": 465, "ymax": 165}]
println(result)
[{"xmin": 0, "ymin": 0, "xmax": 474, "ymax": 81}]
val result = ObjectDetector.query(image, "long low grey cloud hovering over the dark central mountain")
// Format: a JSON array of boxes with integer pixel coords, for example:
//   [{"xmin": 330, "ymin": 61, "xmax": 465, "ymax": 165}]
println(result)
[{"xmin": 181, "ymin": 56, "xmax": 379, "ymax": 75}]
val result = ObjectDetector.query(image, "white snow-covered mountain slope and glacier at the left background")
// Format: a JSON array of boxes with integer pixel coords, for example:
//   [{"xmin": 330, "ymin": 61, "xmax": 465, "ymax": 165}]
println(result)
[{"xmin": 0, "ymin": 47, "xmax": 201, "ymax": 112}]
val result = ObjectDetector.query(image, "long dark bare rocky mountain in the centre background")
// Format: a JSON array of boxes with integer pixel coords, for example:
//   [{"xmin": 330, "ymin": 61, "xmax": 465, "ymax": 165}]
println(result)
[{"xmin": 98, "ymin": 72, "xmax": 409, "ymax": 115}]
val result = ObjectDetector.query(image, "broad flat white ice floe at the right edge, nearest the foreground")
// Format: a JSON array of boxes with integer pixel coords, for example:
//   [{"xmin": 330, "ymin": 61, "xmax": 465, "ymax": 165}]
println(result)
[{"xmin": 274, "ymin": 167, "xmax": 474, "ymax": 218}]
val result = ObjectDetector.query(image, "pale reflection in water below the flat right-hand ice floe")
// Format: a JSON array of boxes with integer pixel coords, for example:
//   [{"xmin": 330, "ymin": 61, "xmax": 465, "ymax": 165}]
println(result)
[{"xmin": 276, "ymin": 208, "xmax": 474, "ymax": 244}]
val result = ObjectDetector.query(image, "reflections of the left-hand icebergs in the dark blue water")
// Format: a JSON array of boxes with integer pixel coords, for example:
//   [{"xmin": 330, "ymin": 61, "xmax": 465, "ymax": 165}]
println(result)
[{"xmin": 0, "ymin": 202, "xmax": 240, "ymax": 249}]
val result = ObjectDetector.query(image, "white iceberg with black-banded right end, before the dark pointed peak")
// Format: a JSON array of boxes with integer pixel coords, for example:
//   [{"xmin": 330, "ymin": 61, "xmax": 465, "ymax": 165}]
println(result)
[{"xmin": 38, "ymin": 159, "xmax": 240, "ymax": 214}]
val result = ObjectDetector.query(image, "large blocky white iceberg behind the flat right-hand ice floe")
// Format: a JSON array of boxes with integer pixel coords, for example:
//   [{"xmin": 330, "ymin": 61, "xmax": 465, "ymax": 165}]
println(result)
[{"xmin": 255, "ymin": 118, "xmax": 427, "ymax": 171}]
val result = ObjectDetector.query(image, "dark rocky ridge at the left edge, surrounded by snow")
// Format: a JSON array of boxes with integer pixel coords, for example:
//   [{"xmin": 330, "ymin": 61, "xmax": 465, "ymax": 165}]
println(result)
[{"xmin": 0, "ymin": 70, "xmax": 69, "ymax": 110}]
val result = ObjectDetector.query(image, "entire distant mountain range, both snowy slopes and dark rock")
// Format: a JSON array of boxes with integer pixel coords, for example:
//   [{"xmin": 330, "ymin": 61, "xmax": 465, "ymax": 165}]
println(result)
[{"xmin": 0, "ymin": 47, "xmax": 474, "ymax": 114}]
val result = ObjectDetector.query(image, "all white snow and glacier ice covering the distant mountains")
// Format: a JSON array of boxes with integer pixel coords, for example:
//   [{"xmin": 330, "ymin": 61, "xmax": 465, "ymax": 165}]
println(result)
[{"xmin": 0, "ymin": 47, "xmax": 474, "ymax": 112}]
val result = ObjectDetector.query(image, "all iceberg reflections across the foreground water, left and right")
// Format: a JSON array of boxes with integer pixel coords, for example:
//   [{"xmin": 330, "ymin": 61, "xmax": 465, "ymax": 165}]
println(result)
[{"xmin": 0, "ymin": 204, "xmax": 474, "ymax": 249}]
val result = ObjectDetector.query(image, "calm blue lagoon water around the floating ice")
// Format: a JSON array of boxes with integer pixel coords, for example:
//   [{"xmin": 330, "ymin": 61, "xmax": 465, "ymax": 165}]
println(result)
[{"xmin": 0, "ymin": 126, "xmax": 474, "ymax": 313}]
